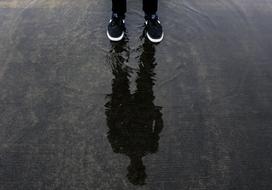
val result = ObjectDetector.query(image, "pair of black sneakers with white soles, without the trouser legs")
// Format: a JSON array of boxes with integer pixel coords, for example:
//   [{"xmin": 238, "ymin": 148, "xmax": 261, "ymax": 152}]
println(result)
[{"xmin": 107, "ymin": 13, "xmax": 163, "ymax": 43}]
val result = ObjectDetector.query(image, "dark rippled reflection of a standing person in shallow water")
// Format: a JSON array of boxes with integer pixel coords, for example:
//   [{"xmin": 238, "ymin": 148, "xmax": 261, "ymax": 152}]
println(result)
[{"xmin": 105, "ymin": 42, "xmax": 163, "ymax": 185}]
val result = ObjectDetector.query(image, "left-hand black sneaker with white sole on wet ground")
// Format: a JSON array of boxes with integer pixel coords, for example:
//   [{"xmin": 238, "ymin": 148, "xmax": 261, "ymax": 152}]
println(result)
[{"xmin": 107, "ymin": 13, "xmax": 125, "ymax": 42}]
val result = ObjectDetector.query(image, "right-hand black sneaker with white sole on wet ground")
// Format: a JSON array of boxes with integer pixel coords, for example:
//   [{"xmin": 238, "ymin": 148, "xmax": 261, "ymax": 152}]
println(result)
[{"xmin": 145, "ymin": 15, "xmax": 163, "ymax": 43}]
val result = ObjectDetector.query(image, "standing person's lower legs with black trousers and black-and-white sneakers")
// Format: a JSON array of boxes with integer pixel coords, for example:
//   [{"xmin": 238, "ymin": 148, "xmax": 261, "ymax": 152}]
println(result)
[{"xmin": 107, "ymin": 0, "xmax": 163, "ymax": 43}]
